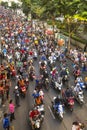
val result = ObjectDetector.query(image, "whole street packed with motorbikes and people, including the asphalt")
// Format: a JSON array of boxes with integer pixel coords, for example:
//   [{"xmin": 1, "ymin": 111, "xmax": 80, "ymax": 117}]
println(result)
[{"xmin": 0, "ymin": 7, "xmax": 87, "ymax": 130}]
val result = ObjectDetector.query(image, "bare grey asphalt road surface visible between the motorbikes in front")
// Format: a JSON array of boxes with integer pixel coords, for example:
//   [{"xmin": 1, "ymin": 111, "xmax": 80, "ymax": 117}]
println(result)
[{"xmin": 0, "ymin": 54, "xmax": 87, "ymax": 130}]
